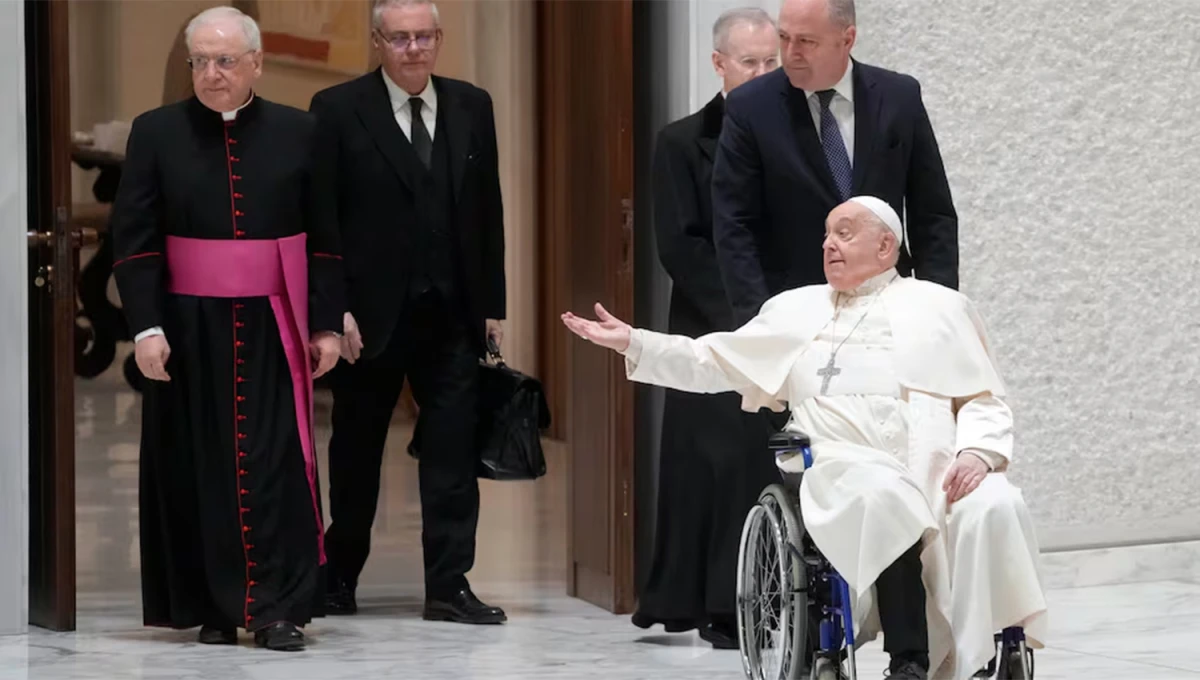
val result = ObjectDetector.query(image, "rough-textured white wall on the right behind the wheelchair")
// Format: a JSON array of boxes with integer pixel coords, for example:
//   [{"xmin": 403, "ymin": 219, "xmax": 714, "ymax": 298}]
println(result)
[{"xmin": 856, "ymin": 0, "xmax": 1200, "ymax": 548}]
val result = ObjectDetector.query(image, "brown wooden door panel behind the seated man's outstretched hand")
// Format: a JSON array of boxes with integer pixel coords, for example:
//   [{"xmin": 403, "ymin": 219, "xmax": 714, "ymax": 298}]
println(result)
[{"xmin": 539, "ymin": 0, "xmax": 634, "ymax": 613}]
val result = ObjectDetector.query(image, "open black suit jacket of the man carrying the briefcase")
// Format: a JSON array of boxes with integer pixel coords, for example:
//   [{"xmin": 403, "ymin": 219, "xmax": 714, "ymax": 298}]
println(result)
[{"xmin": 310, "ymin": 68, "xmax": 505, "ymax": 357}]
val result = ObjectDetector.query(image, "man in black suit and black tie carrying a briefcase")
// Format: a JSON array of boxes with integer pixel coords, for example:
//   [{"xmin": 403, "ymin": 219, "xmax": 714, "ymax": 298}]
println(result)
[{"xmin": 311, "ymin": 0, "xmax": 505, "ymax": 624}]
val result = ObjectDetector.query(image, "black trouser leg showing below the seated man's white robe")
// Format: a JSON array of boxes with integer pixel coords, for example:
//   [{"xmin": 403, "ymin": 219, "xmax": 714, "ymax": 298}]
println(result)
[{"xmin": 875, "ymin": 542, "xmax": 929, "ymax": 670}]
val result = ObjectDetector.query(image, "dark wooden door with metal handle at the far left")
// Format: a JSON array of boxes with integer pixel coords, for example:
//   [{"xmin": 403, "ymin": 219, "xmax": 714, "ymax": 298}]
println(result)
[{"xmin": 24, "ymin": 0, "xmax": 80, "ymax": 631}]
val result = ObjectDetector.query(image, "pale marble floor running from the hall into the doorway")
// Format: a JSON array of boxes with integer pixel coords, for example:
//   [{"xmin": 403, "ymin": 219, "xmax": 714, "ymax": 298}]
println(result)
[{"xmin": 0, "ymin": 347, "xmax": 1200, "ymax": 680}]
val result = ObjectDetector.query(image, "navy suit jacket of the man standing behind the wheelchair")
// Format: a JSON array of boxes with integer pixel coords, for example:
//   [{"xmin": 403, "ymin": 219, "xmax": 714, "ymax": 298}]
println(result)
[{"xmin": 713, "ymin": 61, "xmax": 959, "ymax": 324}]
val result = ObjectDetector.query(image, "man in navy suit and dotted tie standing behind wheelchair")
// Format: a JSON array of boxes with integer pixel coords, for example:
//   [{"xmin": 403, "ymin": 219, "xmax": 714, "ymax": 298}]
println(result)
[{"xmin": 713, "ymin": 0, "xmax": 959, "ymax": 324}]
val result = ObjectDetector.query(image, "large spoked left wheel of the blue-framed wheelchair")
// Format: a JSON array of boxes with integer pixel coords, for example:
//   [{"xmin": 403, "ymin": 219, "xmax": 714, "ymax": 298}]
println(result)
[{"xmin": 737, "ymin": 485, "xmax": 808, "ymax": 680}]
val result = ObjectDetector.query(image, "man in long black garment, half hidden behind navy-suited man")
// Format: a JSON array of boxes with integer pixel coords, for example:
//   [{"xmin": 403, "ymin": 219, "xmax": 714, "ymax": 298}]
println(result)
[{"xmin": 632, "ymin": 7, "xmax": 779, "ymax": 649}]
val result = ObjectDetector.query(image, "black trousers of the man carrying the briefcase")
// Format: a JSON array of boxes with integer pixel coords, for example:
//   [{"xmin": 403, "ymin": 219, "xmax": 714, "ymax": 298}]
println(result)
[{"xmin": 325, "ymin": 289, "xmax": 479, "ymax": 597}]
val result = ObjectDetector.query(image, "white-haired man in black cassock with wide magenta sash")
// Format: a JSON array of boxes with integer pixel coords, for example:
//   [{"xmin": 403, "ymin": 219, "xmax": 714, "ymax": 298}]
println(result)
[{"xmin": 112, "ymin": 7, "xmax": 344, "ymax": 650}]
